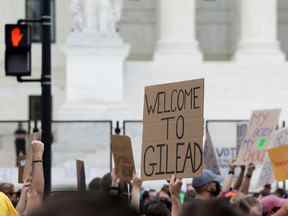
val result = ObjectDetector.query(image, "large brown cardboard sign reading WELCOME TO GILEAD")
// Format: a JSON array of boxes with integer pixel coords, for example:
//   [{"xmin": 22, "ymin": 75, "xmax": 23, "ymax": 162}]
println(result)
[{"xmin": 141, "ymin": 79, "xmax": 204, "ymax": 180}]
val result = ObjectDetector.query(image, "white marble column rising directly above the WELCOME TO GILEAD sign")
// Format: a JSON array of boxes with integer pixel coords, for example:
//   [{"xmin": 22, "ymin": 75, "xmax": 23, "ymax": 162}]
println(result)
[{"xmin": 155, "ymin": 0, "xmax": 202, "ymax": 61}]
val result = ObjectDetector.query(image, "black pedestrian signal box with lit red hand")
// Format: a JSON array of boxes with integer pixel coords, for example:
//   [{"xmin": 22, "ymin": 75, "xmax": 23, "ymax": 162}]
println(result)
[{"xmin": 5, "ymin": 24, "xmax": 31, "ymax": 76}]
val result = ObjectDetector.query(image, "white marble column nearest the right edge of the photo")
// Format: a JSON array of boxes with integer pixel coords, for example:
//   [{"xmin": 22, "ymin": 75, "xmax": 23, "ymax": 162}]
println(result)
[{"xmin": 235, "ymin": 0, "xmax": 285, "ymax": 62}]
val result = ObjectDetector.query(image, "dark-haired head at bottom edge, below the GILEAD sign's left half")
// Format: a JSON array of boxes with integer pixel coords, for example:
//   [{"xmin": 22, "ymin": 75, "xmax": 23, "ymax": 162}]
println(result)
[{"xmin": 144, "ymin": 199, "xmax": 171, "ymax": 216}]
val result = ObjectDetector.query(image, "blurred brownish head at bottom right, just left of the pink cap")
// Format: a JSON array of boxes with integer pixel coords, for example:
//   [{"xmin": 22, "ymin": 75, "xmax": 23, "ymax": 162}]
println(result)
[{"xmin": 231, "ymin": 194, "xmax": 263, "ymax": 216}]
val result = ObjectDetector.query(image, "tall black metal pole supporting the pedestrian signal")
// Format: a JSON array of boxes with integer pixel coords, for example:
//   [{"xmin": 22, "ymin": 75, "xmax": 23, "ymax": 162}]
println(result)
[{"xmin": 41, "ymin": 0, "xmax": 52, "ymax": 194}]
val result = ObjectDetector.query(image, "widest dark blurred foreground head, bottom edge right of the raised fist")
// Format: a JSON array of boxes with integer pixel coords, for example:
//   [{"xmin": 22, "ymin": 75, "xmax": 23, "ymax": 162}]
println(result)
[{"xmin": 30, "ymin": 192, "xmax": 138, "ymax": 216}]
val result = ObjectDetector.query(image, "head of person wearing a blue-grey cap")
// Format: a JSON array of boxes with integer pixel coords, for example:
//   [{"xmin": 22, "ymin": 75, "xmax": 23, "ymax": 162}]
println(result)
[{"xmin": 192, "ymin": 169, "xmax": 223, "ymax": 200}]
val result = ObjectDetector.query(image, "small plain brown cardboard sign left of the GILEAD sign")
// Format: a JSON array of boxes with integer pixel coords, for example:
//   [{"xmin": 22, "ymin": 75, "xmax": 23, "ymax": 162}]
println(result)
[{"xmin": 112, "ymin": 135, "xmax": 135, "ymax": 182}]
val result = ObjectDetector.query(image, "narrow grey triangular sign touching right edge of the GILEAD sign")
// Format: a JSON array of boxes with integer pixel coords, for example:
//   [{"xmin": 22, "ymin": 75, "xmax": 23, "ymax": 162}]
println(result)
[{"xmin": 203, "ymin": 127, "xmax": 221, "ymax": 175}]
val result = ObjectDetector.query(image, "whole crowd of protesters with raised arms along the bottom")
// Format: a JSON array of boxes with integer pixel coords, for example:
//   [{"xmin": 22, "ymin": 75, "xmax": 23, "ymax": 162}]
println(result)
[{"xmin": 0, "ymin": 138, "xmax": 288, "ymax": 216}]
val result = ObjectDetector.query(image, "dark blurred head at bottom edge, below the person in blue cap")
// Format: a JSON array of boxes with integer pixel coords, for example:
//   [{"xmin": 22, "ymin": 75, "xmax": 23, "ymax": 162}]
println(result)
[{"xmin": 182, "ymin": 200, "xmax": 244, "ymax": 216}]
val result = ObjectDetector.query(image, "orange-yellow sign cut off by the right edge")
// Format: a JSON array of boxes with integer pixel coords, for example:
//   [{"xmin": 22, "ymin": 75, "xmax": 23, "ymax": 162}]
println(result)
[{"xmin": 268, "ymin": 145, "xmax": 288, "ymax": 181}]
